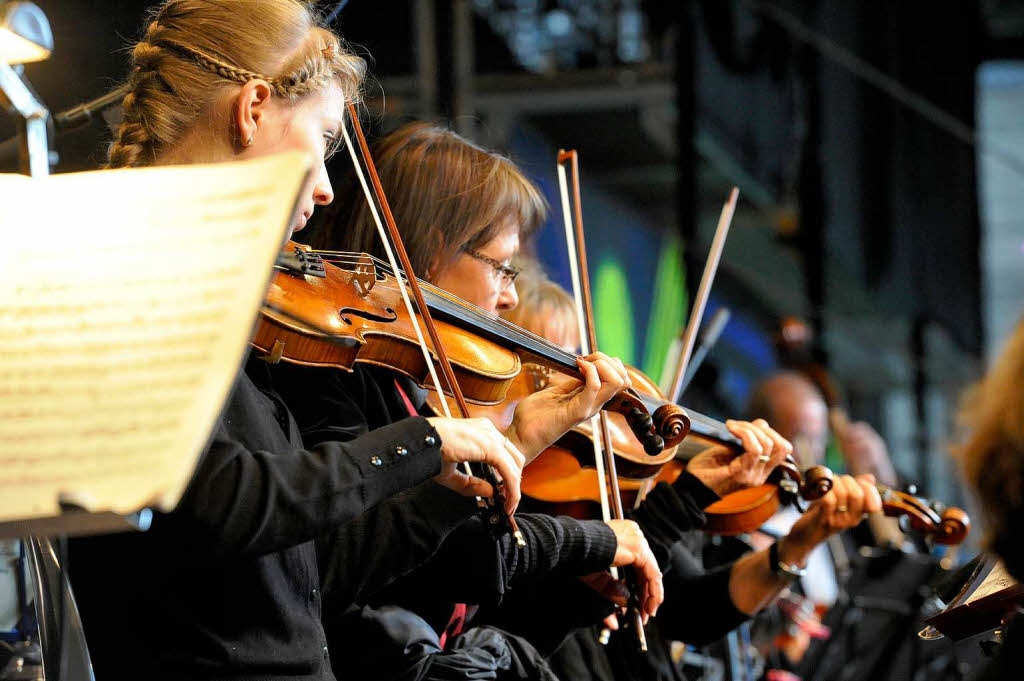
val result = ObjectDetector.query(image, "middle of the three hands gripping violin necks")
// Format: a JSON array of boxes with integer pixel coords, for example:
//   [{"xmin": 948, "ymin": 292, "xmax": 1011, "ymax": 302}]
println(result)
[{"xmin": 686, "ymin": 419, "xmax": 793, "ymax": 497}]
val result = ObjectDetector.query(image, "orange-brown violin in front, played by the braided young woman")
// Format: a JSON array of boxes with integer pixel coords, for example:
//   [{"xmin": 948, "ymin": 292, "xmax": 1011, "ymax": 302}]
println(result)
[{"xmin": 251, "ymin": 242, "xmax": 689, "ymax": 456}]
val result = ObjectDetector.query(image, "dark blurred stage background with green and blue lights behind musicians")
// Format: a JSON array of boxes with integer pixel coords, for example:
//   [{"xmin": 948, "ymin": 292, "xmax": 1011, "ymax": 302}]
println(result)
[{"xmin": 8, "ymin": 0, "xmax": 1024, "ymax": 501}]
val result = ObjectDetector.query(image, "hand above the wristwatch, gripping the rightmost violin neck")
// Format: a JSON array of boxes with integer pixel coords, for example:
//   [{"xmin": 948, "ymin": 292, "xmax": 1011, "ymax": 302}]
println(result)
[{"xmin": 779, "ymin": 475, "xmax": 882, "ymax": 563}]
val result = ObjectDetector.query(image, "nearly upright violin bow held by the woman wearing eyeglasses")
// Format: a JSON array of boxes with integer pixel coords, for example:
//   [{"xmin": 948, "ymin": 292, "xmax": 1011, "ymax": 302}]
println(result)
[{"xmin": 557, "ymin": 150, "xmax": 647, "ymax": 652}]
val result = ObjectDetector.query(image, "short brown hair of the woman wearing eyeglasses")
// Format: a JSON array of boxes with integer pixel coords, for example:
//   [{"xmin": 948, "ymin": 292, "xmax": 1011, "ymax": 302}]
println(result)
[{"xmin": 311, "ymin": 122, "xmax": 547, "ymax": 279}]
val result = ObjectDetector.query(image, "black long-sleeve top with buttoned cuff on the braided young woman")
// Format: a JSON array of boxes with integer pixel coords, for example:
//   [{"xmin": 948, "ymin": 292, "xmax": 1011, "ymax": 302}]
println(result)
[{"xmin": 70, "ymin": 352, "xmax": 450, "ymax": 681}]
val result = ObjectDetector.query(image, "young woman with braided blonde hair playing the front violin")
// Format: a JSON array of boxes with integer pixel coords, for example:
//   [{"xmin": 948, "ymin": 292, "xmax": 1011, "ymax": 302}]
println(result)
[{"xmin": 71, "ymin": 0, "xmax": 561, "ymax": 681}]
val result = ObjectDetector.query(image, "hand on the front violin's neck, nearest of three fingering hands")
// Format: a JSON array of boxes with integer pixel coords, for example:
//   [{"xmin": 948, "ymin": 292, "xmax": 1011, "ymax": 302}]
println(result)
[{"xmin": 506, "ymin": 352, "xmax": 632, "ymax": 461}]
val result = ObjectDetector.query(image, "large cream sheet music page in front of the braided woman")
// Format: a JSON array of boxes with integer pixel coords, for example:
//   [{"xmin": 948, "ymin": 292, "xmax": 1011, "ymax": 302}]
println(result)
[{"xmin": 0, "ymin": 153, "xmax": 309, "ymax": 520}]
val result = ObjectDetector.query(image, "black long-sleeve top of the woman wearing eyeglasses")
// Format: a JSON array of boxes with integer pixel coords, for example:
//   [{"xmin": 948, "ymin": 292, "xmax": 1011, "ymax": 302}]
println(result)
[{"xmin": 272, "ymin": 358, "xmax": 615, "ymax": 606}]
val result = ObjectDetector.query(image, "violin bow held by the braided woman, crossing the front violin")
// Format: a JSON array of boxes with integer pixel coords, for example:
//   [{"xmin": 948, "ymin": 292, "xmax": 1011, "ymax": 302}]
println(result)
[{"xmin": 341, "ymin": 103, "xmax": 526, "ymax": 547}]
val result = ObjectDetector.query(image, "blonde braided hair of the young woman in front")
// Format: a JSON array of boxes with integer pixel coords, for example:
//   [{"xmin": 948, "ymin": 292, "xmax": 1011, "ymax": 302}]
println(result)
[{"xmin": 108, "ymin": 0, "xmax": 366, "ymax": 168}]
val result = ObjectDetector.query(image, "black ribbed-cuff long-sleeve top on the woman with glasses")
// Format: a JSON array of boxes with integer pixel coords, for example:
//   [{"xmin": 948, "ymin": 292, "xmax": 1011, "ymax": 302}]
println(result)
[{"xmin": 274, "ymin": 366, "xmax": 616, "ymax": 670}]
